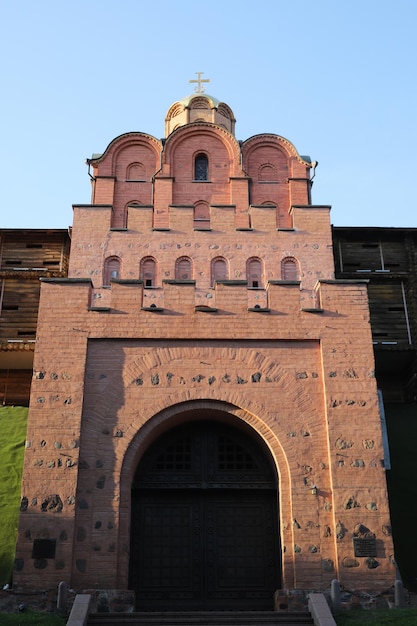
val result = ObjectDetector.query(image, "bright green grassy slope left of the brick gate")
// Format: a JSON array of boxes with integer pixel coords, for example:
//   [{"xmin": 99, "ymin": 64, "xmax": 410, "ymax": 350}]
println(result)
[{"xmin": 0, "ymin": 406, "xmax": 27, "ymax": 584}]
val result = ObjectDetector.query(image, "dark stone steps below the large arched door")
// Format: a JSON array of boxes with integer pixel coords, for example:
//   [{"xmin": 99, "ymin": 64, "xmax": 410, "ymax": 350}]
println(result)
[{"xmin": 88, "ymin": 611, "xmax": 314, "ymax": 626}]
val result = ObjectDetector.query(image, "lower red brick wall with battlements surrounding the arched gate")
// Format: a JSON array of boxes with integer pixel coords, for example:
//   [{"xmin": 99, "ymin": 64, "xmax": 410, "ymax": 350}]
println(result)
[{"xmin": 17, "ymin": 282, "xmax": 392, "ymax": 588}]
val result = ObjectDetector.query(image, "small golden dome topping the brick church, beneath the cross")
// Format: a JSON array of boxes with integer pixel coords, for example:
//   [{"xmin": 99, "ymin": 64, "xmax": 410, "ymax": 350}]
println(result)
[{"xmin": 165, "ymin": 92, "xmax": 236, "ymax": 137}]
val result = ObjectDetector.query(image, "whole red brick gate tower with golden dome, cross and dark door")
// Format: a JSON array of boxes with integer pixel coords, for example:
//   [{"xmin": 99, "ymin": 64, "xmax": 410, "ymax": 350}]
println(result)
[{"xmin": 15, "ymin": 82, "xmax": 394, "ymax": 609}]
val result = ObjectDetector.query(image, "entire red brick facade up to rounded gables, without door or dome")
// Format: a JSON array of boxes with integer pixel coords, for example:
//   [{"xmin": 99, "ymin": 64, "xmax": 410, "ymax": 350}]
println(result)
[{"xmin": 16, "ymin": 113, "xmax": 394, "ymax": 589}]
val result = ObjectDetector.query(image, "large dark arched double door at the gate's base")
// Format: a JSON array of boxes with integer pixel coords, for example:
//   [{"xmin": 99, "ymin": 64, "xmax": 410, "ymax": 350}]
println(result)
[{"xmin": 130, "ymin": 420, "xmax": 281, "ymax": 611}]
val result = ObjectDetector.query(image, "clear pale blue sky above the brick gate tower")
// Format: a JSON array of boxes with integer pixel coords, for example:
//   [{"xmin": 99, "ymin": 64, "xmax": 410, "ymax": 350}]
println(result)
[{"xmin": 0, "ymin": 0, "xmax": 417, "ymax": 228}]
